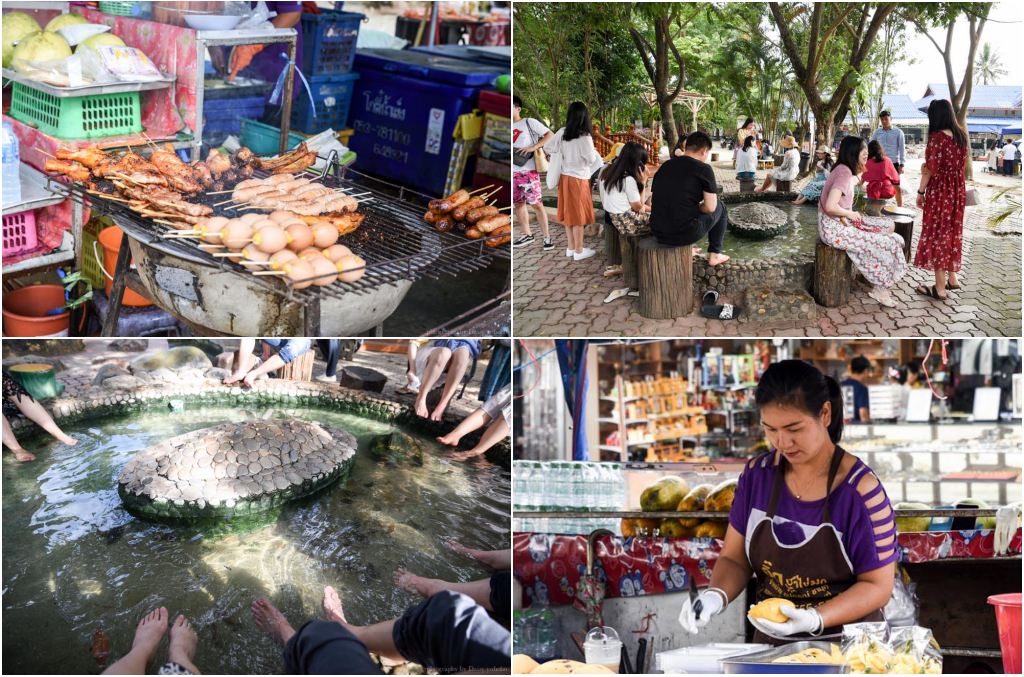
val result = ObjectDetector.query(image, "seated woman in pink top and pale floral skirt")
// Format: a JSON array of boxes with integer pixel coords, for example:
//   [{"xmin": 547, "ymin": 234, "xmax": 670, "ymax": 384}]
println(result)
[{"xmin": 818, "ymin": 136, "xmax": 906, "ymax": 308}]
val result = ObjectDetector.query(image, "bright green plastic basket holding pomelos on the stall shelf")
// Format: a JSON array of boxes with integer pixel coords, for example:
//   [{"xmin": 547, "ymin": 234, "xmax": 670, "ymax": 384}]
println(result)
[{"xmin": 8, "ymin": 82, "xmax": 142, "ymax": 138}]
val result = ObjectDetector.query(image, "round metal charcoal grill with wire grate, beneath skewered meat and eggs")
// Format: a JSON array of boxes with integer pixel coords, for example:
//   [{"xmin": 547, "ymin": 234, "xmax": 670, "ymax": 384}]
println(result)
[{"xmin": 50, "ymin": 151, "xmax": 509, "ymax": 336}]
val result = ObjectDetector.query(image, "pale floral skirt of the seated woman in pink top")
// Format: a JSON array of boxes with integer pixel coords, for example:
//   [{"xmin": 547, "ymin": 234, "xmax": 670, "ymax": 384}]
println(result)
[{"xmin": 818, "ymin": 211, "xmax": 907, "ymax": 288}]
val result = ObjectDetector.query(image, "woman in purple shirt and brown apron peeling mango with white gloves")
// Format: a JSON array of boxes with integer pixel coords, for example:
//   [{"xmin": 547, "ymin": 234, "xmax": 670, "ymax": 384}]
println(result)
[{"xmin": 679, "ymin": 359, "xmax": 897, "ymax": 644}]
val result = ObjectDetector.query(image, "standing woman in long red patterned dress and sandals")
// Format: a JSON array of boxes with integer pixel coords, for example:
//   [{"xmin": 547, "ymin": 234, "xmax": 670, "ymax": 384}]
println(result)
[{"xmin": 913, "ymin": 98, "xmax": 968, "ymax": 300}]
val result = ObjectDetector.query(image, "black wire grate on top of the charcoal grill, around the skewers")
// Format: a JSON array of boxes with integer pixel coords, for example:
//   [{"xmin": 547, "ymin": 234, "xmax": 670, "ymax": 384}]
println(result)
[{"xmin": 49, "ymin": 156, "xmax": 509, "ymax": 304}]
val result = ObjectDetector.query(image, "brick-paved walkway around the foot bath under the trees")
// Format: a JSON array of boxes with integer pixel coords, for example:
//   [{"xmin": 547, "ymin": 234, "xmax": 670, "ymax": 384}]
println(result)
[{"xmin": 513, "ymin": 159, "xmax": 1021, "ymax": 337}]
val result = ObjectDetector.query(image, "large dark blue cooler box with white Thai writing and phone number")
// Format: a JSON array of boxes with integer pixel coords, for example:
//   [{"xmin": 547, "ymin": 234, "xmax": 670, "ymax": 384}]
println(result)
[{"xmin": 349, "ymin": 49, "xmax": 503, "ymax": 195}]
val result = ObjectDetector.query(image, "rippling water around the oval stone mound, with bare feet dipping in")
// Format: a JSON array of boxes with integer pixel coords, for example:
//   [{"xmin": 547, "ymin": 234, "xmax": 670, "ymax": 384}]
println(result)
[{"xmin": 3, "ymin": 409, "xmax": 510, "ymax": 674}]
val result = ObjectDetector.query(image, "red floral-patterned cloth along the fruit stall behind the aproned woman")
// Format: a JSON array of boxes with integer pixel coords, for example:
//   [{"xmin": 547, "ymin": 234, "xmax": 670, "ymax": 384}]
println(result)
[{"xmin": 512, "ymin": 530, "xmax": 1021, "ymax": 606}]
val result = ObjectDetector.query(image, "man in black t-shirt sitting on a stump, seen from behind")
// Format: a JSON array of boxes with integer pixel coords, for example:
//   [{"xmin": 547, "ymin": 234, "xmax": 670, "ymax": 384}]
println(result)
[{"xmin": 650, "ymin": 132, "xmax": 729, "ymax": 265}]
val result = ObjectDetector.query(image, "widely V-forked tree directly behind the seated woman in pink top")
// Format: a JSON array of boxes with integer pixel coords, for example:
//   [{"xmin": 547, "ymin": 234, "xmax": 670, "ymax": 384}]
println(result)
[{"xmin": 768, "ymin": 2, "xmax": 897, "ymax": 144}]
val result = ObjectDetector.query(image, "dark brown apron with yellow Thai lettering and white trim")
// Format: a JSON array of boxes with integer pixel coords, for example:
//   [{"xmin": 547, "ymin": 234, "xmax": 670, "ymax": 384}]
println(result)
[{"xmin": 746, "ymin": 447, "xmax": 885, "ymax": 645}]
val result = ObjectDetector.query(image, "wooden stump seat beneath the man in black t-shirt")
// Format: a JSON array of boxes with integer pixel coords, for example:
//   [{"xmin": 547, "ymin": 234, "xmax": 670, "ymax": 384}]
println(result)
[{"xmin": 637, "ymin": 238, "xmax": 693, "ymax": 320}]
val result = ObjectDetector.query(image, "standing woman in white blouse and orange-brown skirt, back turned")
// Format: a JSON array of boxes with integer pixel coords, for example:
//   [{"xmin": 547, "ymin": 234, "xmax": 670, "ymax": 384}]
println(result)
[{"xmin": 544, "ymin": 101, "xmax": 602, "ymax": 261}]
